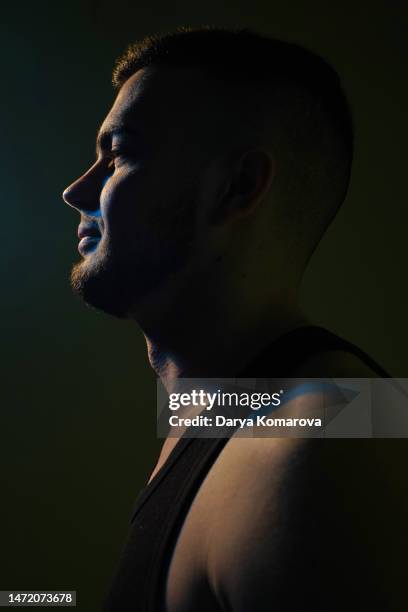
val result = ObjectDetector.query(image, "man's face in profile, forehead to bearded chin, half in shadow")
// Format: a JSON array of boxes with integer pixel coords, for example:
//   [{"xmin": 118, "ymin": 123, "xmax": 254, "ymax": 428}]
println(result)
[{"xmin": 64, "ymin": 71, "xmax": 214, "ymax": 317}]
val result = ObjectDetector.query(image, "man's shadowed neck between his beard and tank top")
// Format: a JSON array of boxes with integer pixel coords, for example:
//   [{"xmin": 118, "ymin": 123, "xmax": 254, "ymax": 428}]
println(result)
[{"xmin": 144, "ymin": 290, "xmax": 309, "ymax": 388}]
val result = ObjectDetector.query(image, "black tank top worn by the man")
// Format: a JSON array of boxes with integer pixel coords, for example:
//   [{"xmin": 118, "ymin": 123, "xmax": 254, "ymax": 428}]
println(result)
[{"xmin": 103, "ymin": 326, "xmax": 389, "ymax": 612}]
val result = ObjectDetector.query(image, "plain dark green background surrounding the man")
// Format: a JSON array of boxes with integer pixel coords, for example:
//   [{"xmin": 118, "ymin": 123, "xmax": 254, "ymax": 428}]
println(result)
[{"xmin": 0, "ymin": 0, "xmax": 408, "ymax": 612}]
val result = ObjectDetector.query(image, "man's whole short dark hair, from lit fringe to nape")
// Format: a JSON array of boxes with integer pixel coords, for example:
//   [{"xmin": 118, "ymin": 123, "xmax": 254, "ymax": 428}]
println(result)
[{"xmin": 113, "ymin": 26, "xmax": 354, "ymax": 252}]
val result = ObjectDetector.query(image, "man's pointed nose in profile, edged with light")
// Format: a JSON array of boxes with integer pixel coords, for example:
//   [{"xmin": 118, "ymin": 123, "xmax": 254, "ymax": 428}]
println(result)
[{"xmin": 62, "ymin": 164, "xmax": 104, "ymax": 216}]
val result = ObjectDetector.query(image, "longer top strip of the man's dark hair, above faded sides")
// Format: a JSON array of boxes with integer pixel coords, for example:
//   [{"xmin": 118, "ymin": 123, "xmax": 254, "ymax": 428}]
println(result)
[{"xmin": 112, "ymin": 26, "xmax": 354, "ymax": 158}]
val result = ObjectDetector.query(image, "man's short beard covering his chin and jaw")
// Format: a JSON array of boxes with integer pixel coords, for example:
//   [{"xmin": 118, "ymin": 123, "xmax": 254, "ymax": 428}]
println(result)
[{"xmin": 71, "ymin": 180, "xmax": 198, "ymax": 319}]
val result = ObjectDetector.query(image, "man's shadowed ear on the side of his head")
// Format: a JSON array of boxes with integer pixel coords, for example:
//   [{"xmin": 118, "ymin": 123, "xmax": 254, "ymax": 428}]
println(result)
[{"xmin": 211, "ymin": 148, "xmax": 275, "ymax": 225}]
